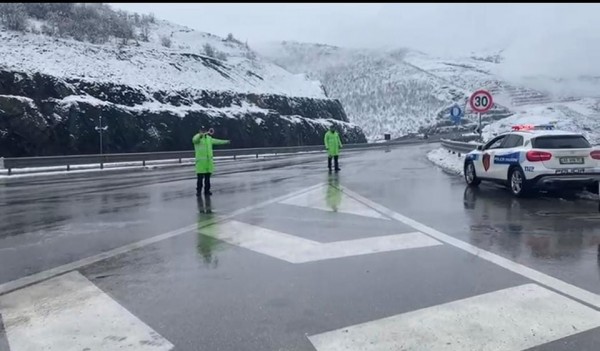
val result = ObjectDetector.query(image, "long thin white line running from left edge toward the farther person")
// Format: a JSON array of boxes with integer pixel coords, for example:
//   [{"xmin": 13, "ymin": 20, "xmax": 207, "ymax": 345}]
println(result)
[{"xmin": 0, "ymin": 183, "xmax": 324, "ymax": 295}]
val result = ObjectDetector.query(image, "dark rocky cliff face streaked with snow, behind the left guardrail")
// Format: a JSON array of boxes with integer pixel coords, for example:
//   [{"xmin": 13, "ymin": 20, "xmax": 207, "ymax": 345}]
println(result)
[{"xmin": 0, "ymin": 70, "xmax": 366, "ymax": 157}]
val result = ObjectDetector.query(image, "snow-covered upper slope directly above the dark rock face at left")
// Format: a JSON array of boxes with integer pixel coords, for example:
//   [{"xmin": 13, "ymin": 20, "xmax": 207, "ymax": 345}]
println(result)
[{"xmin": 0, "ymin": 20, "xmax": 324, "ymax": 98}]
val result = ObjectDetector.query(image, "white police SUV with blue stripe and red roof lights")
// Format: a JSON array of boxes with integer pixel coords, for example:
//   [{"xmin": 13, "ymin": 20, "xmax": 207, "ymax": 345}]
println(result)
[{"xmin": 464, "ymin": 124, "xmax": 600, "ymax": 196}]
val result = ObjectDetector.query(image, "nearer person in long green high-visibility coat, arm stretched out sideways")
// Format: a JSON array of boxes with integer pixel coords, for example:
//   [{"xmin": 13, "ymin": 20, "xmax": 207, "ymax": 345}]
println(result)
[{"xmin": 192, "ymin": 127, "xmax": 230, "ymax": 196}]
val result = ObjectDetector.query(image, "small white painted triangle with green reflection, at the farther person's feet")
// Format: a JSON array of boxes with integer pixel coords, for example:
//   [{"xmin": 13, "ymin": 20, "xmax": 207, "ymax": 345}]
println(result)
[{"xmin": 280, "ymin": 186, "xmax": 389, "ymax": 220}]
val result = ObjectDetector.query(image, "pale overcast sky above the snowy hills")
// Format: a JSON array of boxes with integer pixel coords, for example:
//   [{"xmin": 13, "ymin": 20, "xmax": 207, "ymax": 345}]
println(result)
[{"xmin": 111, "ymin": 3, "xmax": 600, "ymax": 53}]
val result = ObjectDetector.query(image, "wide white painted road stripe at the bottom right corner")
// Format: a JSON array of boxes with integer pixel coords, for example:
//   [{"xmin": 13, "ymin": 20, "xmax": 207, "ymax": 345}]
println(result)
[{"xmin": 309, "ymin": 284, "xmax": 600, "ymax": 351}]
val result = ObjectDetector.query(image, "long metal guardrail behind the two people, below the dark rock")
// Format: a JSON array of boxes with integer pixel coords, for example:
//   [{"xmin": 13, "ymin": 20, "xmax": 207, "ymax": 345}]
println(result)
[{"xmin": 0, "ymin": 140, "xmax": 423, "ymax": 175}]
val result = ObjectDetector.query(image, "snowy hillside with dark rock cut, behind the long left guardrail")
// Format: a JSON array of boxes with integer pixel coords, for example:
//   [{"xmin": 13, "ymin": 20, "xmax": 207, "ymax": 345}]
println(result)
[{"xmin": 0, "ymin": 4, "xmax": 366, "ymax": 157}]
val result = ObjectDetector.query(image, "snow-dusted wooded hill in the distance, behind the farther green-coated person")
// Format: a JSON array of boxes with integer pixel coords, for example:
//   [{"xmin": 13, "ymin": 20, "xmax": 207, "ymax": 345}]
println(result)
[{"xmin": 256, "ymin": 42, "xmax": 465, "ymax": 139}]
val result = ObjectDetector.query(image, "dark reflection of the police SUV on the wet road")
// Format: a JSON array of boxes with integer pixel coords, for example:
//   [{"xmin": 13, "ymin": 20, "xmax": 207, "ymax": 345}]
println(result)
[{"xmin": 463, "ymin": 187, "xmax": 600, "ymax": 264}]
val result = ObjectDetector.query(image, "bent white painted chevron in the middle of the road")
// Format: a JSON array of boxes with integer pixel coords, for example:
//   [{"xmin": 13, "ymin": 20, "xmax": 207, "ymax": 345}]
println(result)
[{"xmin": 200, "ymin": 220, "xmax": 442, "ymax": 263}]
